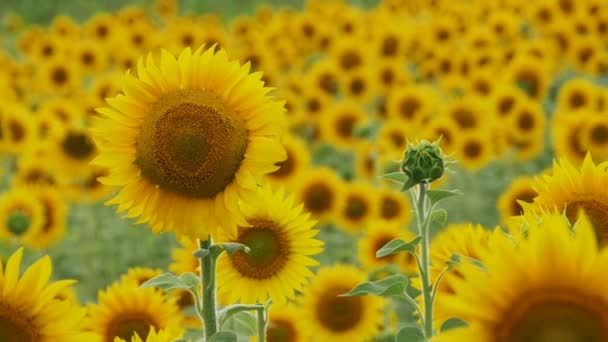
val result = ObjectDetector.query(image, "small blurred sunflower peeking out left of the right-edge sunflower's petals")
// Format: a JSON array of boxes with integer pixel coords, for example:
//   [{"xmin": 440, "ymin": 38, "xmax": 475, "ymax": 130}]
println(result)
[{"xmin": 497, "ymin": 176, "xmax": 537, "ymax": 223}]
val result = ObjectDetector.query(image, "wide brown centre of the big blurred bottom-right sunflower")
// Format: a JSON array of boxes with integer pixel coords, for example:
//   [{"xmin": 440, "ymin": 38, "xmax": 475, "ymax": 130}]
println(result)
[{"xmin": 494, "ymin": 289, "xmax": 608, "ymax": 342}]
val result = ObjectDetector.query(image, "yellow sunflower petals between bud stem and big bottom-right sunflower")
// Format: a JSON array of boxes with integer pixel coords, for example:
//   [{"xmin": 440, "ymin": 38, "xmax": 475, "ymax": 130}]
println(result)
[{"xmin": 431, "ymin": 224, "xmax": 502, "ymax": 326}]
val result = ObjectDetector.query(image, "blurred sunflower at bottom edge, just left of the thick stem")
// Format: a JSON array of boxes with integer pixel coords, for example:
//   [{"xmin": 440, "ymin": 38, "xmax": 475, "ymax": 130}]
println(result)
[{"xmin": 87, "ymin": 282, "xmax": 183, "ymax": 342}]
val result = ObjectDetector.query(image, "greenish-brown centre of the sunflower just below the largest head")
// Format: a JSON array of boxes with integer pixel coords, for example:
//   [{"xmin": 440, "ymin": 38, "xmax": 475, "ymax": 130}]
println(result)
[{"xmin": 230, "ymin": 220, "xmax": 289, "ymax": 279}]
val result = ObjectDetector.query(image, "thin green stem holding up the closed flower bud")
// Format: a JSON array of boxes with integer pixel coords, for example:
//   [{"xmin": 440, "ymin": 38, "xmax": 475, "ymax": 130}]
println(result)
[{"xmin": 416, "ymin": 183, "xmax": 433, "ymax": 339}]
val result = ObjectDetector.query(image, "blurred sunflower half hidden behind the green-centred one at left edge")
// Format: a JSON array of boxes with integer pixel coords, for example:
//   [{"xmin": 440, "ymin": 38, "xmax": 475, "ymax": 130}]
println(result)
[{"xmin": 28, "ymin": 186, "xmax": 68, "ymax": 249}]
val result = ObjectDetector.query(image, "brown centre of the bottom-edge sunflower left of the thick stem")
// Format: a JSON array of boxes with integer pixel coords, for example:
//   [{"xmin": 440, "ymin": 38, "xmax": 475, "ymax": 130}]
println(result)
[{"xmin": 105, "ymin": 312, "xmax": 159, "ymax": 342}]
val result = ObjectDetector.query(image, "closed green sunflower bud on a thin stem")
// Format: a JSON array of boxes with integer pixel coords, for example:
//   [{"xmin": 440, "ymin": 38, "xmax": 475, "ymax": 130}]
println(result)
[{"xmin": 401, "ymin": 140, "xmax": 445, "ymax": 187}]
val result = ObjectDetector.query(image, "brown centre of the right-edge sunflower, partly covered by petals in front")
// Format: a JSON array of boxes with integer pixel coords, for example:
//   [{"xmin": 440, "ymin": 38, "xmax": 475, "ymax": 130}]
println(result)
[{"xmin": 566, "ymin": 199, "xmax": 608, "ymax": 246}]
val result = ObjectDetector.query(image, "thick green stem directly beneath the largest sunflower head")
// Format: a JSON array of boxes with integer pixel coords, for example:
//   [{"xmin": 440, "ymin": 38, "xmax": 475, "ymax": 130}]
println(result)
[{"xmin": 199, "ymin": 237, "xmax": 217, "ymax": 340}]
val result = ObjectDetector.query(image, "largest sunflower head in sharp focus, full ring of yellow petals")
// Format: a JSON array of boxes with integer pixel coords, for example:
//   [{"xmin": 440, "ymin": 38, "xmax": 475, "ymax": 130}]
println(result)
[{"xmin": 92, "ymin": 48, "xmax": 285, "ymax": 238}]
